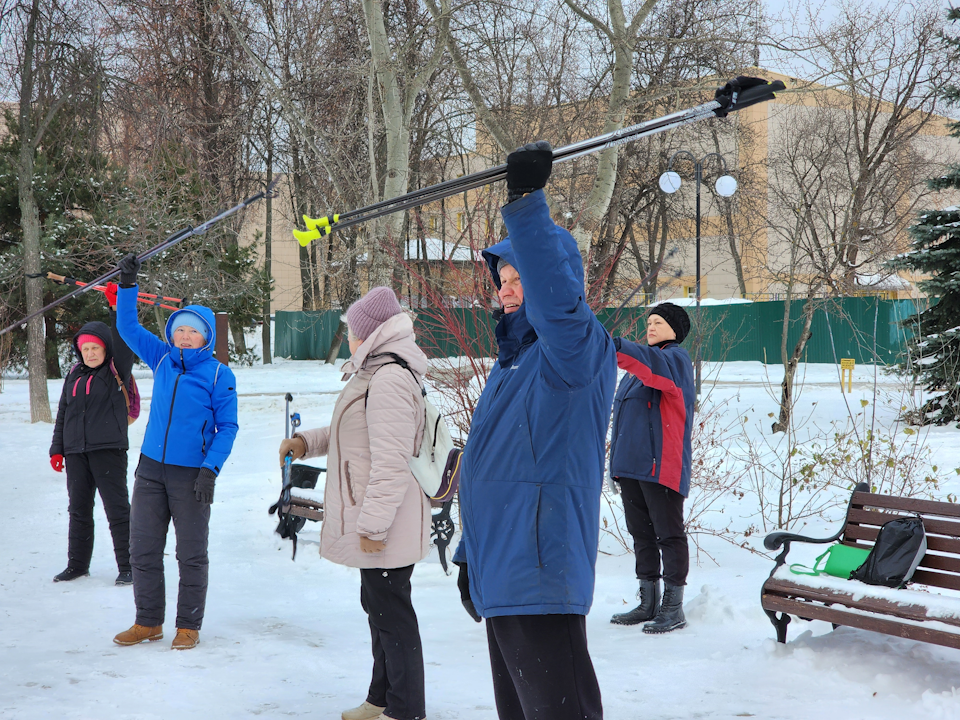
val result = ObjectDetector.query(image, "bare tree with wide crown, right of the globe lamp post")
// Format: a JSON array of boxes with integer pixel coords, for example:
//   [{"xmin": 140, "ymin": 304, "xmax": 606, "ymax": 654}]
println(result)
[{"xmin": 767, "ymin": 2, "xmax": 951, "ymax": 432}]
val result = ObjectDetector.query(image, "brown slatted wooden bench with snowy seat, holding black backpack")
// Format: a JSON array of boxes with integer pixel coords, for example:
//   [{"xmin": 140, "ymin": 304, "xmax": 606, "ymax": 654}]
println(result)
[{"xmin": 760, "ymin": 483, "xmax": 960, "ymax": 649}]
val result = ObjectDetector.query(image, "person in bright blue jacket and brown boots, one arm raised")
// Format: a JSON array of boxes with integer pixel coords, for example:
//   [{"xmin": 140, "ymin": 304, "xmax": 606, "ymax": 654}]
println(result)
[{"xmin": 113, "ymin": 255, "xmax": 237, "ymax": 650}]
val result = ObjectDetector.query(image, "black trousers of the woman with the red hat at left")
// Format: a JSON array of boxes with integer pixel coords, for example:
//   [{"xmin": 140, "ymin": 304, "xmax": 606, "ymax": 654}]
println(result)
[{"xmin": 64, "ymin": 450, "xmax": 130, "ymax": 572}]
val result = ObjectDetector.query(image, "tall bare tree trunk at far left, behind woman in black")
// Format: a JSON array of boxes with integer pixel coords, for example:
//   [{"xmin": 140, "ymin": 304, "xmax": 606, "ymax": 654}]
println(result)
[{"xmin": 17, "ymin": 0, "xmax": 53, "ymax": 422}]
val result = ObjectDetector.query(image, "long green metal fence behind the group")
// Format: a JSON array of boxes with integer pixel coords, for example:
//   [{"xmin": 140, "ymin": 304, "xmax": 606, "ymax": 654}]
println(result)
[{"xmin": 274, "ymin": 297, "xmax": 915, "ymax": 364}]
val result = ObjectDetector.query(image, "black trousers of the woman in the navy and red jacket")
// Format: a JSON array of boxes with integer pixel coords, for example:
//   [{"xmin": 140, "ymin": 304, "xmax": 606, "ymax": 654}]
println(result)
[{"xmin": 619, "ymin": 478, "xmax": 690, "ymax": 586}]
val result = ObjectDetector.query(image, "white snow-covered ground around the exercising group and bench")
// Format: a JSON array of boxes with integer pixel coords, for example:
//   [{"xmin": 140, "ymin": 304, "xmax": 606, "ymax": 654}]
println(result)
[{"xmin": 0, "ymin": 361, "xmax": 960, "ymax": 720}]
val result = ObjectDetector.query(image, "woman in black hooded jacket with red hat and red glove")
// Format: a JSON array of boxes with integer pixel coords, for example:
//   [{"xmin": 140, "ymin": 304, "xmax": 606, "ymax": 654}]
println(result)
[{"xmin": 50, "ymin": 292, "xmax": 133, "ymax": 585}]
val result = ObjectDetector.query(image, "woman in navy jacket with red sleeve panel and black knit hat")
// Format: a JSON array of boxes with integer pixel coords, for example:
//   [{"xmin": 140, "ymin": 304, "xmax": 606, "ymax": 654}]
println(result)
[{"xmin": 610, "ymin": 302, "xmax": 696, "ymax": 634}]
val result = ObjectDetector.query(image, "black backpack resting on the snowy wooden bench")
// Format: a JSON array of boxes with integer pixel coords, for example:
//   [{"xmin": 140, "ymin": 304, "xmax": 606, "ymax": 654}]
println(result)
[{"xmin": 850, "ymin": 517, "xmax": 927, "ymax": 588}]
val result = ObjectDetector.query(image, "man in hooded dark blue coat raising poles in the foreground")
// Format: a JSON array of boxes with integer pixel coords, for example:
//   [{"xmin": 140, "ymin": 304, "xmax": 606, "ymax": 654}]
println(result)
[{"xmin": 454, "ymin": 141, "xmax": 617, "ymax": 720}]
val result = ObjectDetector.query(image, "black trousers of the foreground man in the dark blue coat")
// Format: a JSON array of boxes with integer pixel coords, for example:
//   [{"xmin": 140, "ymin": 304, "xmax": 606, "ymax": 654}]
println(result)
[{"xmin": 487, "ymin": 615, "xmax": 603, "ymax": 720}]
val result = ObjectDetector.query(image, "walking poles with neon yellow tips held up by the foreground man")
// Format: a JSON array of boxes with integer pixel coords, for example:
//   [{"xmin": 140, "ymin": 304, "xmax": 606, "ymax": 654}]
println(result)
[{"xmin": 293, "ymin": 76, "xmax": 785, "ymax": 247}]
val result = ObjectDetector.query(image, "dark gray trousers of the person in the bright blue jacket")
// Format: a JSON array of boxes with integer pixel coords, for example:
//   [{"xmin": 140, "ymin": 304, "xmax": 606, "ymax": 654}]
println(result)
[{"xmin": 130, "ymin": 457, "xmax": 210, "ymax": 630}]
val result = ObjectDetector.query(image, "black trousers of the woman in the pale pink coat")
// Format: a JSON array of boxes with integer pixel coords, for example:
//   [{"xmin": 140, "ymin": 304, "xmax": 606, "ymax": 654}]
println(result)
[{"xmin": 360, "ymin": 565, "xmax": 426, "ymax": 720}]
